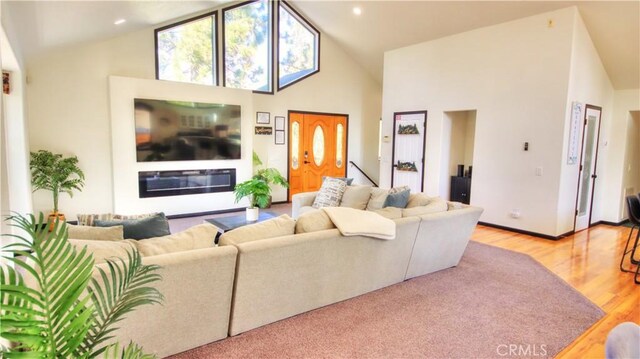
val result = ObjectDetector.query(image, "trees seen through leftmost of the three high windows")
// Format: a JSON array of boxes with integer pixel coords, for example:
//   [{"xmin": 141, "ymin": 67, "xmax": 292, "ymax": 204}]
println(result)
[{"xmin": 156, "ymin": 13, "xmax": 217, "ymax": 85}]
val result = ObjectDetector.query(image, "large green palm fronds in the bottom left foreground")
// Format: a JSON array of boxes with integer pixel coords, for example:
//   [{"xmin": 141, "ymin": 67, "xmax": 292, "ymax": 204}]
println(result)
[{"xmin": 0, "ymin": 213, "xmax": 163, "ymax": 359}]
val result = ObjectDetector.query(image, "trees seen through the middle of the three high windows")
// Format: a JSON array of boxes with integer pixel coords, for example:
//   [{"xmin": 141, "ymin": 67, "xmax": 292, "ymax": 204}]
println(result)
[{"xmin": 223, "ymin": 0, "xmax": 273, "ymax": 92}]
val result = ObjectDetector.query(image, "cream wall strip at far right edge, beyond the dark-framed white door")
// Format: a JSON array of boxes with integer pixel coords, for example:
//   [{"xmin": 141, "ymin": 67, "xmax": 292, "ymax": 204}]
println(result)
[{"xmin": 598, "ymin": 89, "xmax": 640, "ymax": 223}]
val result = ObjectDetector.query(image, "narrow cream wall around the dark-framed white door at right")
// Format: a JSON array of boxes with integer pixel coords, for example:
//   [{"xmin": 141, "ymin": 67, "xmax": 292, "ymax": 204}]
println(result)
[{"xmin": 556, "ymin": 11, "xmax": 613, "ymax": 234}]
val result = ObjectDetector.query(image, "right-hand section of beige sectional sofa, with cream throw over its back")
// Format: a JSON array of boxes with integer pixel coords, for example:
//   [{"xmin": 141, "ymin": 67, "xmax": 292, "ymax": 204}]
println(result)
[{"xmin": 220, "ymin": 193, "xmax": 482, "ymax": 335}]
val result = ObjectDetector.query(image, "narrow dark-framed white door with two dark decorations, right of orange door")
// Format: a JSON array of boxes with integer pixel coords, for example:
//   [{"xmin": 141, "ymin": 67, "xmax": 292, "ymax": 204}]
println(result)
[{"xmin": 391, "ymin": 111, "xmax": 427, "ymax": 192}]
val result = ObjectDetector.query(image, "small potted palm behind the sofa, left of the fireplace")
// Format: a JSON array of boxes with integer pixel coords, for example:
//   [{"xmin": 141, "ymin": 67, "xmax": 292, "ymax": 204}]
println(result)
[{"xmin": 29, "ymin": 150, "xmax": 84, "ymax": 223}]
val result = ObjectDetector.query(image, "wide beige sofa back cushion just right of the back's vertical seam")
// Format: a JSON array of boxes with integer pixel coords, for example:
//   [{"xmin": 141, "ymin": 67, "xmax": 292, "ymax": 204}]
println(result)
[{"xmin": 219, "ymin": 214, "xmax": 296, "ymax": 245}]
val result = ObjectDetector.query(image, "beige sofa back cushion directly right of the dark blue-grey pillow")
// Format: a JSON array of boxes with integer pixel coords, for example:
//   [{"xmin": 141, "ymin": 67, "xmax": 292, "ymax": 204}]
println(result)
[{"xmin": 135, "ymin": 223, "xmax": 218, "ymax": 257}]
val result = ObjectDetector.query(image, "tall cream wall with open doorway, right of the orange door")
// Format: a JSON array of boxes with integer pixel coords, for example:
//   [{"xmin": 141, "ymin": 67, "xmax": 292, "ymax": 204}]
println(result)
[{"xmin": 380, "ymin": 8, "xmax": 577, "ymax": 236}]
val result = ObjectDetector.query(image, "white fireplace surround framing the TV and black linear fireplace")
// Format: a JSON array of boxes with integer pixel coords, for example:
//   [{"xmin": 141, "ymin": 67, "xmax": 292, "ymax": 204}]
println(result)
[{"xmin": 105, "ymin": 76, "xmax": 254, "ymax": 215}]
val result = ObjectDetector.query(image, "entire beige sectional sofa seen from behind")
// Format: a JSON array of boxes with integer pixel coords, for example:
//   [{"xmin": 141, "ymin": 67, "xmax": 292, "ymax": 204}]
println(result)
[{"xmin": 70, "ymin": 188, "xmax": 482, "ymax": 357}]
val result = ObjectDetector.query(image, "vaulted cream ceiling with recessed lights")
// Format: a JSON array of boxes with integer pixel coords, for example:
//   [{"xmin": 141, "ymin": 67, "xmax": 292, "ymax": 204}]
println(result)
[{"xmin": 2, "ymin": 0, "xmax": 640, "ymax": 89}]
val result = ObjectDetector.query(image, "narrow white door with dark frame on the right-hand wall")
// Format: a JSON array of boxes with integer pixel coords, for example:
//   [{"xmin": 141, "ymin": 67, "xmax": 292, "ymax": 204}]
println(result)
[{"xmin": 574, "ymin": 105, "xmax": 602, "ymax": 231}]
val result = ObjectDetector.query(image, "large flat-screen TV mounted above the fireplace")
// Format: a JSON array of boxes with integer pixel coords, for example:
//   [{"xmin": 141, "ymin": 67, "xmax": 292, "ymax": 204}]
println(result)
[{"xmin": 134, "ymin": 98, "xmax": 241, "ymax": 162}]
